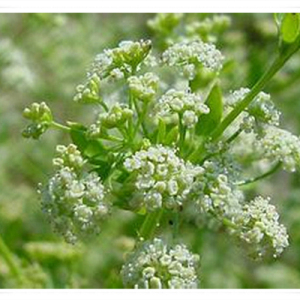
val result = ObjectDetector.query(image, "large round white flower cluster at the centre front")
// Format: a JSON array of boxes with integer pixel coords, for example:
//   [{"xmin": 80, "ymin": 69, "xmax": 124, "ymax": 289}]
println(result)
[{"xmin": 124, "ymin": 145, "xmax": 203, "ymax": 211}]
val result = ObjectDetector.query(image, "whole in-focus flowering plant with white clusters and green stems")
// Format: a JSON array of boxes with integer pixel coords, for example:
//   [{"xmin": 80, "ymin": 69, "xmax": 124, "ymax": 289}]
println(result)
[{"xmin": 13, "ymin": 14, "xmax": 300, "ymax": 288}]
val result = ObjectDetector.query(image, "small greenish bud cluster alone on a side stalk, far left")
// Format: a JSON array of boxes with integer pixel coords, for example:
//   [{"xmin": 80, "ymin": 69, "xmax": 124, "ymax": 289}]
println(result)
[{"xmin": 22, "ymin": 102, "xmax": 52, "ymax": 139}]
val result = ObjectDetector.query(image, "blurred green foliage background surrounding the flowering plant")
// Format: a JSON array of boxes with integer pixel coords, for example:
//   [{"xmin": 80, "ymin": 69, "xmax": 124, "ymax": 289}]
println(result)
[{"xmin": 0, "ymin": 14, "xmax": 300, "ymax": 288}]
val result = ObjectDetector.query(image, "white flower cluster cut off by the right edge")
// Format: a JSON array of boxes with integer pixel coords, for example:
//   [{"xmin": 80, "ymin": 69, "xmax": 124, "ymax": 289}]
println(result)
[{"xmin": 257, "ymin": 126, "xmax": 300, "ymax": 172}]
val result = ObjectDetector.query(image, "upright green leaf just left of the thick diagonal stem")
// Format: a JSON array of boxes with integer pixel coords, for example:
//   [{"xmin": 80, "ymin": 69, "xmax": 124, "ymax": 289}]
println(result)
[{"xmin": 196, "ymin": 83, "xmax": 223, "ymax": 136}]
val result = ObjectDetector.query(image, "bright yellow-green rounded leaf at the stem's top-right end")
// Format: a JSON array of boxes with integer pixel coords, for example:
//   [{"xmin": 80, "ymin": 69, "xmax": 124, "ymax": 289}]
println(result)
[{"xmin": 281, "ymin": 13, "xmax": 300, "ymax": 44}]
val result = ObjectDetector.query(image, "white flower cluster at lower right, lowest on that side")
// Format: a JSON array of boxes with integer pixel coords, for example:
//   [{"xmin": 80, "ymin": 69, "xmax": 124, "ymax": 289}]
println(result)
[{"xmin": 238, "ymin": 196, "xmax": 289, "ymax": 257}]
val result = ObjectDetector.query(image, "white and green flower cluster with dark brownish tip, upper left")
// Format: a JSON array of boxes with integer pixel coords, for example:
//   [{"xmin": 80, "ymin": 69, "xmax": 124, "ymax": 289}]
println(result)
[{"xmin": 88, "ymin": 40, "xmax": 151, "ymax": 79}]
